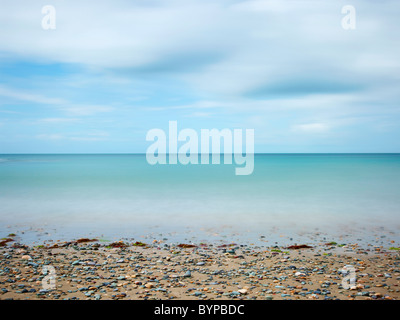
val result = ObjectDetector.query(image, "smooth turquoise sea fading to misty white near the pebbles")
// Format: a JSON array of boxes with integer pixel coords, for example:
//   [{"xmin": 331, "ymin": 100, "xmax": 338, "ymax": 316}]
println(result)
[{"xmin": 0, "ymin": 154, "xmax": 400, "ymax": 243}]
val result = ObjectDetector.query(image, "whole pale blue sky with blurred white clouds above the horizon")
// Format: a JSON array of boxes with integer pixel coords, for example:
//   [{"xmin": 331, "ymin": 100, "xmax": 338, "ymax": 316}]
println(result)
[{"xmin": 0, "ymin": 0, "xmax": 400, "ymax": 154}]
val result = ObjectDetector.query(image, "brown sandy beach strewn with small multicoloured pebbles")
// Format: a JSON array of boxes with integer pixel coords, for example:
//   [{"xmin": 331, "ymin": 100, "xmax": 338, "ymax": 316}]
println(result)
[{"xmin": 0, "ymin": 235, "xmax": 400, "ymax": 300}]
